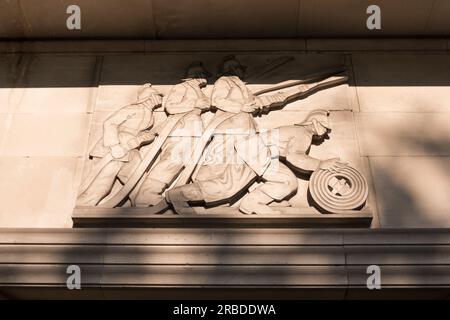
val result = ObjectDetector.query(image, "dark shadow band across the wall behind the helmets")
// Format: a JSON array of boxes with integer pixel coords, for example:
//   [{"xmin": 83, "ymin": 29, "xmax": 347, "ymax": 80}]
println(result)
[{"xmin": 0, "ymin": 52, "xmax": 450, "ymax": 88}]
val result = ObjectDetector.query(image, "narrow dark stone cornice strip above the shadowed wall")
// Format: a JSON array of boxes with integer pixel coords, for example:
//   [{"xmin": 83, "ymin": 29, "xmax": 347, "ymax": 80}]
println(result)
[{"xmin": 0, "ymin": 38, "xmax": 450, "ymax": 54}]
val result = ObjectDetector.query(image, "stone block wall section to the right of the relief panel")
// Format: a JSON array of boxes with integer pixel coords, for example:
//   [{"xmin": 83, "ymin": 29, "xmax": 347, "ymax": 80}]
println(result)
[{"xmin": 352, "ymin": 53, "xmax": 450, "ymax": 228}]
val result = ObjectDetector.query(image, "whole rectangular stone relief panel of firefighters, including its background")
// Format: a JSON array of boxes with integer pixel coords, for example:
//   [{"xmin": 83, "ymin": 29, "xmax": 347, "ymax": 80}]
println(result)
[{"xmin": 77, "ymin": 54, "xmax": 369, "ymax": 220}]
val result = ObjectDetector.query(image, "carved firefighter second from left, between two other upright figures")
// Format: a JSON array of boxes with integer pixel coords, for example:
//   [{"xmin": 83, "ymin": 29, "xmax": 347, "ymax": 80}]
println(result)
[{"xmin": 132, "ymin": 61, "xmax": 210, "ymax": 207}]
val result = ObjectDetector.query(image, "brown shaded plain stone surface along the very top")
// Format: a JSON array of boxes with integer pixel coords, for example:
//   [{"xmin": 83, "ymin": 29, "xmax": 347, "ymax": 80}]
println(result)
[{"xmin": 0, "ymin": 0, "xmax": 450, "ymax": 39}]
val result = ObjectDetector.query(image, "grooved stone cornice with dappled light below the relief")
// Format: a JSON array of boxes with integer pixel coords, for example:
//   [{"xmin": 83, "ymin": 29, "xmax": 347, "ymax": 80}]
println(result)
[{"xmin": 0, "ymin": 228, "xmax": 450, "ymax": 298}]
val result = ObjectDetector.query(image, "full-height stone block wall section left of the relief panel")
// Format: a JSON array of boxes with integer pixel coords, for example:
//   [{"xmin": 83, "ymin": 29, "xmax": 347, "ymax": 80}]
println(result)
[{"xmin": 0, "ymin": 54, "xmax": 97, "ymax": 227}]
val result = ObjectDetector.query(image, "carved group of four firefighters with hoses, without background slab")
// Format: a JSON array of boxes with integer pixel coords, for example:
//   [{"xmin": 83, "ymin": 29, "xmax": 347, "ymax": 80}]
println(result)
[{"xmin": 77, "ymin": 56, "xmax": 368, "ymax": 215}]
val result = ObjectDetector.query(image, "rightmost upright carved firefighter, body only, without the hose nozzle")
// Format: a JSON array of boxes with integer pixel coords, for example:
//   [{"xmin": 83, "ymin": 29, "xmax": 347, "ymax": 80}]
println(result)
[{"xmin": 166, "ymin": 58, "xmax": 260, "ymax": 213}]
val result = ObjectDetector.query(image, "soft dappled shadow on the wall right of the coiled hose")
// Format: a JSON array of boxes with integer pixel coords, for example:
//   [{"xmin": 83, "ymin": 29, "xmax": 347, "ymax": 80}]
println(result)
[{"xmin": 369, "ymin": 113, "xmax": 450, "ymax": 228}]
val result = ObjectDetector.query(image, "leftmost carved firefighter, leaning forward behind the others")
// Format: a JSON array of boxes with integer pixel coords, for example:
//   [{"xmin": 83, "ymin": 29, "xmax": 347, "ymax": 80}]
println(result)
[{"xmin": 77, "ymin": 84, "xmax": 162, "ymax": 206}]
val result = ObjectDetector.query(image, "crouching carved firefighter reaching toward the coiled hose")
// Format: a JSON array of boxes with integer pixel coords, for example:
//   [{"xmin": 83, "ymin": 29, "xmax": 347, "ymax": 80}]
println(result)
[{"xmin": 236, "ymin": 110, "xmax": 346, "ymax": 214}]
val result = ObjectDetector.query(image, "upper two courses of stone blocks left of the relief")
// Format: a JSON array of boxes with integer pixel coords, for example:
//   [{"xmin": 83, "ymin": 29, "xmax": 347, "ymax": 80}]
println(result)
[{"xmin": 0, "ymin": 55, "xmax": 96, "ymax": 157}]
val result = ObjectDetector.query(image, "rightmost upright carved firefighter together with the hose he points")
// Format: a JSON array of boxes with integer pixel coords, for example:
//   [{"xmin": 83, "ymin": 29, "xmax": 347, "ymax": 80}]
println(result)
[{"xmin": 166, "ymin": 56, "xmax": 347, "ymax": 214}]
